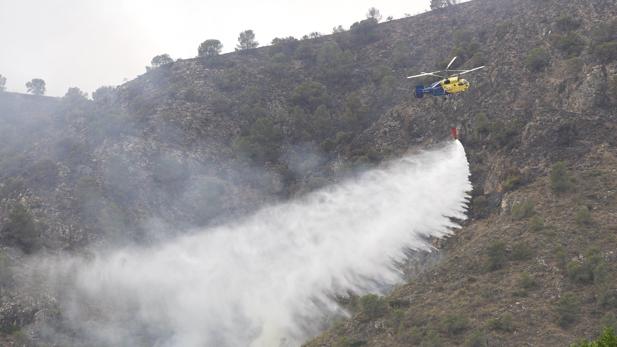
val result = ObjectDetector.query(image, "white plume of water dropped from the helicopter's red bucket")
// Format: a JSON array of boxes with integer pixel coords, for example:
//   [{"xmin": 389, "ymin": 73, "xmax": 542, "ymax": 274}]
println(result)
[{"xmin": 31, "ymin": 142, "xmax": 471, "ymax": 346}]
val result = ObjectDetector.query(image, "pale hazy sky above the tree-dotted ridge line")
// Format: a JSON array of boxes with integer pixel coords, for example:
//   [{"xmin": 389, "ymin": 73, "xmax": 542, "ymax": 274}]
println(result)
[{"xmin": 0, "ymin": 0, "xmax": 442, "ymax": 96}]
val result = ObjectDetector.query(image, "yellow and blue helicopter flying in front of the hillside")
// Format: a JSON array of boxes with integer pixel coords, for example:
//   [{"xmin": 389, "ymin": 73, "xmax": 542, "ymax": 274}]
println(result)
[{"xmin": 407, "ymin": 57, "xmax": 485, "ymax": 99}]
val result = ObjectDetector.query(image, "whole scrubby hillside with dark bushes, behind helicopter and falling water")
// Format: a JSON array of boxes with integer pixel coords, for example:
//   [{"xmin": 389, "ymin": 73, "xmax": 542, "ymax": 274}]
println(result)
[{"xmin": 0, "ymin": 0, "xmax": 617, "ymax": 346}]
